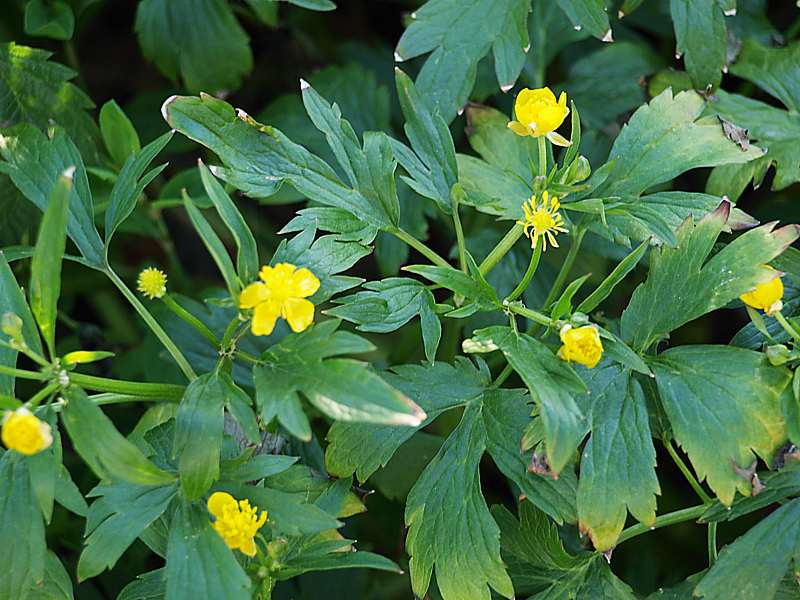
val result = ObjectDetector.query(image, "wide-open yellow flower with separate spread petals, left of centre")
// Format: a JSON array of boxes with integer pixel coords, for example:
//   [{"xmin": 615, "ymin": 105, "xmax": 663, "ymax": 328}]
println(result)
[{"xmin": 239, "ymin": 263, "xmax": 319, "ymax": 335}]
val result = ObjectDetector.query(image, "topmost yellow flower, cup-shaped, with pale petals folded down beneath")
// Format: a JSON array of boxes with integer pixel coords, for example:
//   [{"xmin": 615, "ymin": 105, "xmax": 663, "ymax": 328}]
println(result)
[{"xmin": 508, "ymin": 87, "xmax": 571, "ymax": 146}]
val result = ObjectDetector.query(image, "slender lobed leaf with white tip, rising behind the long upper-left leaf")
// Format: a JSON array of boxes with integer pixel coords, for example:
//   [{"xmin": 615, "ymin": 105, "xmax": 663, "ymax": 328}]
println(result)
[{"xmin": 300, "ymin": 80, "xmax": 400, "ymax": 226}]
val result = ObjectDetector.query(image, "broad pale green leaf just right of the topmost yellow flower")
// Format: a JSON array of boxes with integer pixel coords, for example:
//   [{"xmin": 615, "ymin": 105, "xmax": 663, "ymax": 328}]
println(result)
[{"xmin": 591, "ymin": 89, "xmax": 764, "ymax": 197}]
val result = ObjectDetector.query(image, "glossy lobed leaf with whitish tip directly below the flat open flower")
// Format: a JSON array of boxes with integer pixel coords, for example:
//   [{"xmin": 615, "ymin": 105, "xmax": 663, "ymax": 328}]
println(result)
[{"xmin": 253, "ymin": 321, "xmax": 426, "ymax": 434}]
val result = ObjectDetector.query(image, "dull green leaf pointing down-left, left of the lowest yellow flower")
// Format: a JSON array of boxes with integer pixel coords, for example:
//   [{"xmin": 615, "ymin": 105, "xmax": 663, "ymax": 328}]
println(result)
[{"xmin": 78, "ymin": 482, "xmax": 177, "ymax": 581}]
